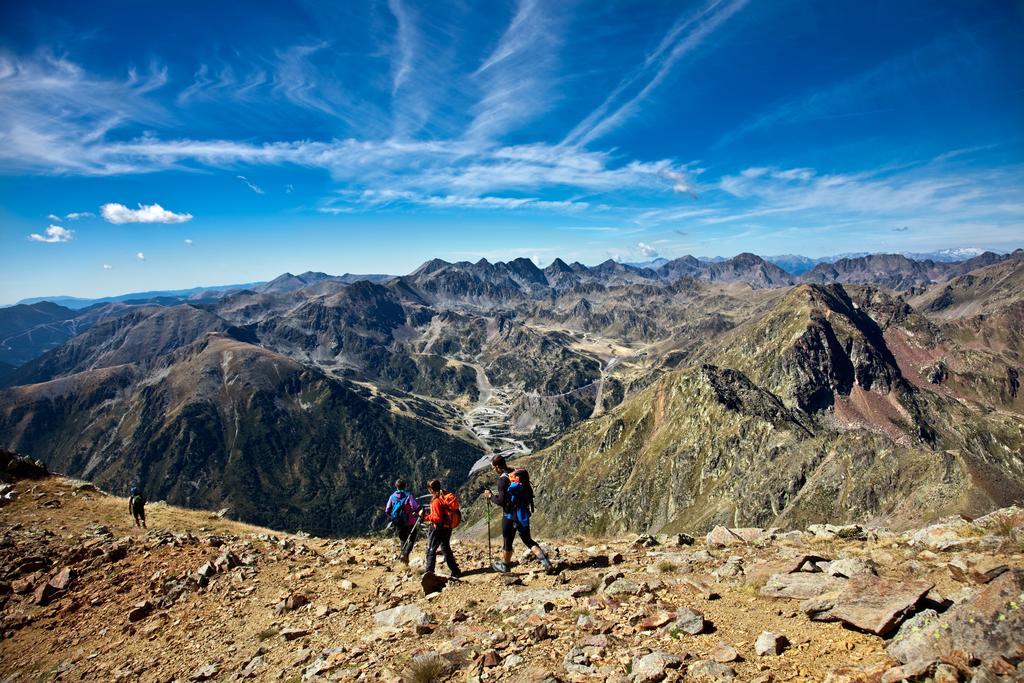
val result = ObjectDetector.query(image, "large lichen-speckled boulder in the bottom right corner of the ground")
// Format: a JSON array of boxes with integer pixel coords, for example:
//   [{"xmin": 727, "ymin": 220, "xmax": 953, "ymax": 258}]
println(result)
[{"xmin": 886, "ymin": 569, "xmax": 1024, "ymax": 665}]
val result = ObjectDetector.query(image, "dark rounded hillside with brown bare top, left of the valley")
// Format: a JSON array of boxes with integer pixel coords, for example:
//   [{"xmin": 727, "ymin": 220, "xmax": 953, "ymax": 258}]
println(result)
[{"xmin": 0, "ymin": 333, "xmax": 482, "ymax": 533}]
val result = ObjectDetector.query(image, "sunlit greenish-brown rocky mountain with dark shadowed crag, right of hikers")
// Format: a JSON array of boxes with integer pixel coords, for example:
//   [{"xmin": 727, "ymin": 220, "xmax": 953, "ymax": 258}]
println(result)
[{"xmin": 522, "ymin": 285, "xmax": 1024, "ymax": 533}]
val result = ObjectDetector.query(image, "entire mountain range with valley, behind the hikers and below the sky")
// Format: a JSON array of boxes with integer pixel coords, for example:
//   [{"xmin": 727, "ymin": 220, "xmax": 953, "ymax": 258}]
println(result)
[{"xmin": 0, "ymin": 245, "xmax": 1024, "ymax": 533}]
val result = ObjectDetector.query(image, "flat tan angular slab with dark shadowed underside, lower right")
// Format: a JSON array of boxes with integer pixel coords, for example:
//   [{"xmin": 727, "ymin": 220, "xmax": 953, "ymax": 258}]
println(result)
[{"xmin": 805, "ymin": 573, "xmax": 934, "ymax": 636}]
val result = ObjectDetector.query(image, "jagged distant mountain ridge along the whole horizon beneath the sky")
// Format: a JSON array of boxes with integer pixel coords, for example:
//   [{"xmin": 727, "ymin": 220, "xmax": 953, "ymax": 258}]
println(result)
[{"xmin": 6, "ymin": 249, "xmax": 1010, "ymax": 366}]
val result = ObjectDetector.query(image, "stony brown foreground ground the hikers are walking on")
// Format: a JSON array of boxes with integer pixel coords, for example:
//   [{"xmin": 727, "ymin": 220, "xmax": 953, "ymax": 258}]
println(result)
[{"xmin": 0, "ymin": 477, "xmax": 1024, "ymax": 683}]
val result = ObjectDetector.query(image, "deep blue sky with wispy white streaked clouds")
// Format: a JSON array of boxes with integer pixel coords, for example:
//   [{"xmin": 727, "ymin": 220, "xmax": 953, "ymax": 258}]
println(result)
[{"xmin": 0, "ymin": 0, "xmax": 1024, "ymax": 302}]
